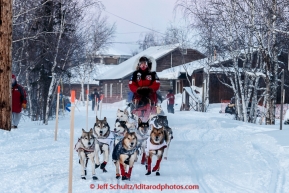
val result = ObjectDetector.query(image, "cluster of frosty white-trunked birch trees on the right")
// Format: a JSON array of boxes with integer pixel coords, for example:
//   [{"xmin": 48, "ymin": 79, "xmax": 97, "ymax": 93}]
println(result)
[{"xmin": 178, "ymin": 0, "xmax": 288, "ymax": 124}]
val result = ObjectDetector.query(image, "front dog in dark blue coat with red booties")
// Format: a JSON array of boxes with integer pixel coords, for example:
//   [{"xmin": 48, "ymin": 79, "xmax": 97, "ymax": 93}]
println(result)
[{"xmin": 112, "ymin": 132, "xmax": 137, "ymax": 180}]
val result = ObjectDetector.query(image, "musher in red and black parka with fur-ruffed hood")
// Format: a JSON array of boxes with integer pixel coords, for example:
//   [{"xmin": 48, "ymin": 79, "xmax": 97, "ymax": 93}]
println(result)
[{"xmin": 129, "ymin": 56, "xmax": 160, "ymax": 106}]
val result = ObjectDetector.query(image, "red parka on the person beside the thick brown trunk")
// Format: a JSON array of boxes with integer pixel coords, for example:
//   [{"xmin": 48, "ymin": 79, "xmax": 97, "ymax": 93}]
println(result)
[{"xmin": 12, "ymin": 83, "xmax": 27, "ymax": 113}]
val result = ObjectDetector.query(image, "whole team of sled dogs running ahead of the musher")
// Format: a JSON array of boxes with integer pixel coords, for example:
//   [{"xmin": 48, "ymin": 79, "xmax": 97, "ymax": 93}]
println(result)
[{"xmin": 75, "ymin": 107, "xmax": 173, "ymax": 180}]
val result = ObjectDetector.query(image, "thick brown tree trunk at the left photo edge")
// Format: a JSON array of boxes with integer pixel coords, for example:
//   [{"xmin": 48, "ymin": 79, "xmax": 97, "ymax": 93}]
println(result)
[{"xmin": 0, "ymin": 0, "xmax": 12, "ymax": 131}]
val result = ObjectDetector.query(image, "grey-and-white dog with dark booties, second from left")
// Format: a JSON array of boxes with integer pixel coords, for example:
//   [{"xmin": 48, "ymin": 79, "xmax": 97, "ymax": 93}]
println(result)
[{"xmin": 94, "ymin": 117, "xmax": 114, "ymax": 172}]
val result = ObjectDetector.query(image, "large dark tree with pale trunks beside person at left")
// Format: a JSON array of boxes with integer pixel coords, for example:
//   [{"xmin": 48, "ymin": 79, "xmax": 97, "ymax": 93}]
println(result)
[{"xmin": 13, "ymin": 0, "xmax": 106, "ymax": 124}]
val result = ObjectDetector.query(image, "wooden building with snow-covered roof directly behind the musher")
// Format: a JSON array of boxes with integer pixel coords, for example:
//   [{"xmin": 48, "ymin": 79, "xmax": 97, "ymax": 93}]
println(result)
[{"xmin": 97, "ymin": 45, "xmax": 205, "ymax": 103}]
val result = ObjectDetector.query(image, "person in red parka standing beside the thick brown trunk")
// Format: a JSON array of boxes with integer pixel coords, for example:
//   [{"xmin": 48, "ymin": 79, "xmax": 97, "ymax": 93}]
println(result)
[{"xmin": 11, "ymin": 74, "xmax": 27, "ymax": 129}]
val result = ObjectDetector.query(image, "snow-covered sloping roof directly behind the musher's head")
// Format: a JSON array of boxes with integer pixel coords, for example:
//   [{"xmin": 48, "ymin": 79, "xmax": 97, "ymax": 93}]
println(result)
[{"xmin": 97, "ymin": 44, "xmax": 178, "ymax": 80}]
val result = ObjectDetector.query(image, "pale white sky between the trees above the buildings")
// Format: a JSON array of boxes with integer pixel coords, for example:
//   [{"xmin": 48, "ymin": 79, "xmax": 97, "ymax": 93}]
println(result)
[{"xmin": 102, "ymin": 0, "xmax": 180, "ymax": 54}]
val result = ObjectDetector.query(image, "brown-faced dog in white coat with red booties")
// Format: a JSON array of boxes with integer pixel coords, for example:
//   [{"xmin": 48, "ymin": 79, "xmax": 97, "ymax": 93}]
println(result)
[{"xmin": 146, "ymin": 125, "xmax": 167, "ymax": 176}]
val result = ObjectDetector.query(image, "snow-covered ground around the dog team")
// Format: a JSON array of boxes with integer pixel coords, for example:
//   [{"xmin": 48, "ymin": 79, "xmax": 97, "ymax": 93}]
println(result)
[{"xmin": 0, "ymin": 95, "xmax": 289, "ymax": 193}]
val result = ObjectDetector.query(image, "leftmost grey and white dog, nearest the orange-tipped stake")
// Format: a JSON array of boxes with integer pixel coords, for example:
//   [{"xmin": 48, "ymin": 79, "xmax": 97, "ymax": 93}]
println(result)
[{"xmin": 74, "ymin": 129, "xmax": 98, "ymax": 180}]
